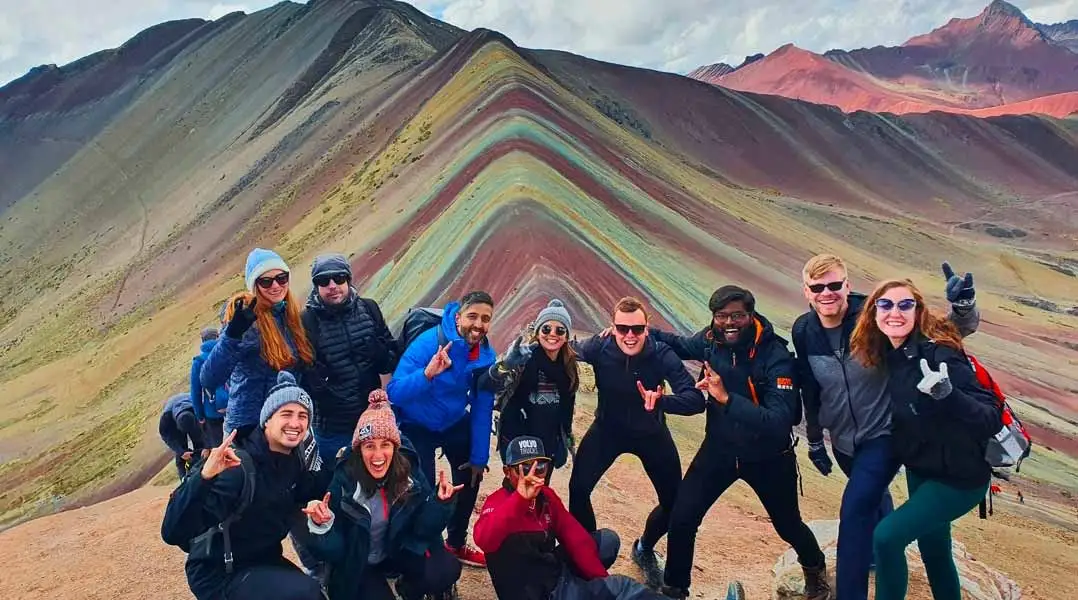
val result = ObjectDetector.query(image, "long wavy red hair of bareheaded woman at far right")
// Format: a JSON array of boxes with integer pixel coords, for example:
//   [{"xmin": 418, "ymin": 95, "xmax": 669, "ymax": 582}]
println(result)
[{"xmin": 849, "ymin": 279, "xmax": 963, "ymax": 367}]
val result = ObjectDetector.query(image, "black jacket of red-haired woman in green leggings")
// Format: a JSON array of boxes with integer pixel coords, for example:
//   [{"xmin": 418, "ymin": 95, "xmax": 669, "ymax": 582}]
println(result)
[{"xmin": 885, "ymin": 334, "xmax": 1003, "ymax": 489}]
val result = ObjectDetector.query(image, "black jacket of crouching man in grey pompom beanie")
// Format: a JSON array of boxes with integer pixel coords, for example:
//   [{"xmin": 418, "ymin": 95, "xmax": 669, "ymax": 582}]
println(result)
[{"xmin": 161, "ymin": 429, "xmax": 332, "ymax": 600}]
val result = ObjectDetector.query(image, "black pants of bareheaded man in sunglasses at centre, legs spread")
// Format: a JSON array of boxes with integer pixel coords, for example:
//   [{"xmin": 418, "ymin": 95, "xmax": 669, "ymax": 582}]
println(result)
[{"xmin": 569, "ymin": 421, "xmax": 681, "ymax": 548}]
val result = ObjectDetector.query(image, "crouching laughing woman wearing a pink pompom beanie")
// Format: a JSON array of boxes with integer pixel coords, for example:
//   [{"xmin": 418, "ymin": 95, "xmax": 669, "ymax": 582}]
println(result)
[{"xmin": 304, "ymin": 389, "xmax": 462, "ymax": 600}]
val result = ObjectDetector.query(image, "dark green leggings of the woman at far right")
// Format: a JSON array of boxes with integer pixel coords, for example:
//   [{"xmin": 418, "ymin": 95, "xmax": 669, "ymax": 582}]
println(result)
[{"xmin": 872, "ymin": 471, "xmax": 989, "ymax": 600}]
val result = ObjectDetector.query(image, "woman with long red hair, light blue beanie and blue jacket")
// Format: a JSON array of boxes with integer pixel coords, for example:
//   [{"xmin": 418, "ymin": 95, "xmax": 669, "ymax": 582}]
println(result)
[{"xmin": 199, "ymin": 248, "xmax": 314, "ymax": 437}]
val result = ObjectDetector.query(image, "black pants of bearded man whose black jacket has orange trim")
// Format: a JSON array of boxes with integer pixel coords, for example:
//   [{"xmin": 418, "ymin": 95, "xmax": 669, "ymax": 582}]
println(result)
[{"xmin": 664, "ymin": 438, "xmax": 824, "ymax": 588}]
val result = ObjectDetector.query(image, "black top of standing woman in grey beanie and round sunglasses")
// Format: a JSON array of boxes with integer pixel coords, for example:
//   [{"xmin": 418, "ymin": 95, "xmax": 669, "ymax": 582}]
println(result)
[{"xmin": 489, "ymin": 348, "xmax": 577, "ymax": 468}]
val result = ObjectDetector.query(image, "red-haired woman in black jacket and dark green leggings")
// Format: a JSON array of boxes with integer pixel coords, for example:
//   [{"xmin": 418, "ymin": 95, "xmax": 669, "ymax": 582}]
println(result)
[{"xmin": 851, "ymin": 280, "xmax": 1001, "ymax": 600}]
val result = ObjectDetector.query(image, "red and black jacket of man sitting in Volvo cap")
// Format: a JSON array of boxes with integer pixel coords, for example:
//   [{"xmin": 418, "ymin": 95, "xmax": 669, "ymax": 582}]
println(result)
[{"xmin": 472, "ymin": 480, "xmax": 608, "ymax": 600}]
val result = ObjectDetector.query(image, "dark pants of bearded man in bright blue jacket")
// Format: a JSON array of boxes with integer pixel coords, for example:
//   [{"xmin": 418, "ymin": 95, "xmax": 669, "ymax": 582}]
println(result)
[{"xmin": 401, "ymin": 415, "xmax": 483, "ymax": 548}]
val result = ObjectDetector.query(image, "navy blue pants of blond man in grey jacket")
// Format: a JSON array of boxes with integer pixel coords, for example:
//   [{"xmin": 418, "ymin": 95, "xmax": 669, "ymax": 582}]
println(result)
[{"xmin": 834, "ymin": 435, "xmax": 899, "ymax": 600}]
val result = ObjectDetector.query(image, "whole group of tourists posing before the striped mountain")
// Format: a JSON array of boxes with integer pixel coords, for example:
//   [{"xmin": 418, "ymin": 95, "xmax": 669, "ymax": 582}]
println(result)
[{"xmin": 161, "ymin": 244, "xmax": 1001, "ymax": 600}]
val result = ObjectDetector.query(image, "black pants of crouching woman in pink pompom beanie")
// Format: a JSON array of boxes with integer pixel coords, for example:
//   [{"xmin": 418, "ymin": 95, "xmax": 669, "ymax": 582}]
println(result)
[{"xmin": 349, "ymin": 546, "xmax": 460, "ymax": 600}]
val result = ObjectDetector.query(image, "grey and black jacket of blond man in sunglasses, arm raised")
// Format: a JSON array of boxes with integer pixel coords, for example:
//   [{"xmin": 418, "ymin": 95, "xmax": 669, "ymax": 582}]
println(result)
[{"xmin": 791, "ymin": 292, "xmax": 981, "ymax": 457}]
